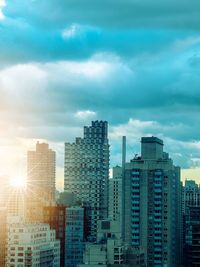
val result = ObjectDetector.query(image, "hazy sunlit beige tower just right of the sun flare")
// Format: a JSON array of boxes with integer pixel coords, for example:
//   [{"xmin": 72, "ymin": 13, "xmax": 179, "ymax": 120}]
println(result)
[{"xmin": 27, "ymin": 142, "xmax": 56, "ymax": 222}]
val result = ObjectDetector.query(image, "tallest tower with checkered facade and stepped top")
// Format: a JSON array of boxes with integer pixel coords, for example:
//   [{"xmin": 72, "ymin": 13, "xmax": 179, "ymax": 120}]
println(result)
[{"xmin": 64, "ymin": 121, "xmax": 109, "ymax": 241}]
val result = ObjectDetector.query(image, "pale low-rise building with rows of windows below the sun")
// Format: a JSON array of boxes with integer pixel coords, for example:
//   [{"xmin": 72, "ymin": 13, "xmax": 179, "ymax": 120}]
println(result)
[{"xmin": 6, "ymin": 218, "xmax": 60, "ymax": 267}]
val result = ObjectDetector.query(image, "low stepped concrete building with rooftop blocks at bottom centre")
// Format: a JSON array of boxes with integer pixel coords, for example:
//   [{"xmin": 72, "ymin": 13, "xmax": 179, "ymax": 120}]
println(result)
[{"xmin": 78, "ymin": 220, "xmax": 146, "ymax": 267}]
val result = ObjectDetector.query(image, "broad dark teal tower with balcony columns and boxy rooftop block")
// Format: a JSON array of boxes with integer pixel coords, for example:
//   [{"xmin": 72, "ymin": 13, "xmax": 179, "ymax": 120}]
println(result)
[{"xmin": 123, "ymin": 137, "xmax": 182, "ymax": 267}]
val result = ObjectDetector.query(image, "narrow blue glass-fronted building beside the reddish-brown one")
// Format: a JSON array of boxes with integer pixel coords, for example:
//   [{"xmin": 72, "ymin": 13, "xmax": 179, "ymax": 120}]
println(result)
[{"xmin": 65, "ymin": 207, "xmax": 84, "ymax": 267}]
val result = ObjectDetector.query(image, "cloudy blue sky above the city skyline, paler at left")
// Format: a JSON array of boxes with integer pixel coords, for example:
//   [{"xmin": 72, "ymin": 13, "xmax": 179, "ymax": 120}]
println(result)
[{"xmin": 0, "ymin": 0, "xmax": 200, "ymax": 189}]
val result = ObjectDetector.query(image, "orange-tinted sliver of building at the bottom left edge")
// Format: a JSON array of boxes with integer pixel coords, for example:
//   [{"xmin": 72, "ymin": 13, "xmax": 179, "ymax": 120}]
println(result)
[{"xmin": 0, "ymin": 208, "xmax": 7, "ymax": 267}]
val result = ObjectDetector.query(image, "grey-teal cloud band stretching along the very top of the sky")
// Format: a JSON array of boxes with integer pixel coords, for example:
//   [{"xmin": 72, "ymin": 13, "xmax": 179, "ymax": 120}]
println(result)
[{"xmin": 5, "ymin": 0, "xmax": 200, "ymax": 29}]
